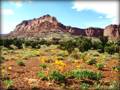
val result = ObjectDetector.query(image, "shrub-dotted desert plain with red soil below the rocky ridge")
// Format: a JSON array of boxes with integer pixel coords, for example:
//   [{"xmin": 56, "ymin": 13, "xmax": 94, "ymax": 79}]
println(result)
[{"xmin": 0, "ymin": 36, "xmax": 120, "ymax": 90}]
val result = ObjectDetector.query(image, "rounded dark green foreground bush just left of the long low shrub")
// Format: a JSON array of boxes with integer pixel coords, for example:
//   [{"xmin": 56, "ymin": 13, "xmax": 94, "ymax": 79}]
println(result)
[{"xmin": 50, "ymin": 71, "xmax": 65, "ymax": 82}]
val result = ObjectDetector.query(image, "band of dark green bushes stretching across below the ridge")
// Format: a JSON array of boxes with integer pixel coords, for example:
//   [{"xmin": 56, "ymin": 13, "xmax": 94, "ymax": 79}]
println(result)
[{"xmin": 0, "ymin": 37, "xmax": 120, "ymax": 54}]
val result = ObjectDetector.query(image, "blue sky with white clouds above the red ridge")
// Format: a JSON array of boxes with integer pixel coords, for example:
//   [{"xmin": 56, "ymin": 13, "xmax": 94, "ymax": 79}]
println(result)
[{"xmin": 0, "ymin": 0, "xmax": 119, "ymax": 34}]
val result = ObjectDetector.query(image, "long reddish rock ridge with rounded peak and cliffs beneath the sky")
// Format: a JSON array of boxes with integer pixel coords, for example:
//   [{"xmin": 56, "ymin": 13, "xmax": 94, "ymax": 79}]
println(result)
[{"xmin": 8, "ymin": 15, "xmax": 120, "ymax": 39}]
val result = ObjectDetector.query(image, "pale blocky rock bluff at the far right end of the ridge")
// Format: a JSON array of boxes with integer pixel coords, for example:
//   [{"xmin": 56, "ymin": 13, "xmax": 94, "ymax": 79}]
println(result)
[{"xmin": 104, "ymin": 25, "xmax": 120, "ymax": 40}]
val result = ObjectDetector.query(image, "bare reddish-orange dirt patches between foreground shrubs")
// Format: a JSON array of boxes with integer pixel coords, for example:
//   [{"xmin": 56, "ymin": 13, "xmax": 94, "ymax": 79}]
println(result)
[{"xmin": 1, "ymin": 56, "xmax": 119, "ymax": 90}]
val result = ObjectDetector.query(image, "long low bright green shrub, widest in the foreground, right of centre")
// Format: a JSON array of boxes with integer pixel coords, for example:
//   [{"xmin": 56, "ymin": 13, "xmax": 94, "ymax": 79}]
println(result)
[{"xmin": 68, "ymin": 70, "xmax": 102, "ymax": 80}]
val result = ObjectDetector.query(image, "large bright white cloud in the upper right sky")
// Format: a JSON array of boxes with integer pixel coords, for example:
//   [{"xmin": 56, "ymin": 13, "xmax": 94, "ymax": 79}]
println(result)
[{"xmin": 72, "ymin": 1, "xmax": 119, "ymax": 24}]
